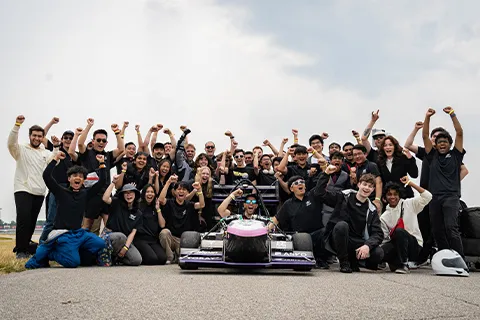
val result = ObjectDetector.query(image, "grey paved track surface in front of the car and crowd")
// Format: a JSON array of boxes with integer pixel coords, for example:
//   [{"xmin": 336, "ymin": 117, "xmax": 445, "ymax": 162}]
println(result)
[{"xmin": 0, "ymin": 265, "xmax": 480, "ymax": 320}]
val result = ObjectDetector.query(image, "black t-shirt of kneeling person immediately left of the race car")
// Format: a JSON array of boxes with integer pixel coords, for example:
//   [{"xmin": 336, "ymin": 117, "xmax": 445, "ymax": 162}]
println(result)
[{"xmin": 162, "ymin": 199, "xmax": 200, "ymax": 238}]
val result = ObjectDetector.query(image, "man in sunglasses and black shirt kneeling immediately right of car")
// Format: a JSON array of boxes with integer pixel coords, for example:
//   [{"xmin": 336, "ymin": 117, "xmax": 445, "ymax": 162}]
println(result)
[{"xmin": 270, "ymin": 175, "xmax": 329, "ymax": 269}]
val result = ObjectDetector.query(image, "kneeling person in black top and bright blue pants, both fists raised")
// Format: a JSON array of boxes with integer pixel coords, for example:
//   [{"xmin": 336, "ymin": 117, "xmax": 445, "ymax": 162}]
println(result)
[{"xmin": 25, "ymin": 152, "xmax": 109, "ymax": 269}]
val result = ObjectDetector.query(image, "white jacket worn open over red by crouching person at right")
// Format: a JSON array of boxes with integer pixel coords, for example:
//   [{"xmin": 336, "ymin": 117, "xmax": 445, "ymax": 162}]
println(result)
[{"xmin": 380, "ymin": 190, "xmax": 432, "ymax": 247}]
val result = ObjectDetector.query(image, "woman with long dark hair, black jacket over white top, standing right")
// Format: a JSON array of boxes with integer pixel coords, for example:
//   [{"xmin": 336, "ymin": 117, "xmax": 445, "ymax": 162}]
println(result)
[{"xmin": 377, "ymin": 136, "xmax": 418, "ymax": 198}]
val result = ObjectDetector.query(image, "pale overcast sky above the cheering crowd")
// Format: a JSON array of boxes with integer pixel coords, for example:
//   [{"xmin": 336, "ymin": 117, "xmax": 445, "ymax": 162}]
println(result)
[{"xmin": 0, "ymin": 0, "xmax": 480, "ymax": 221}]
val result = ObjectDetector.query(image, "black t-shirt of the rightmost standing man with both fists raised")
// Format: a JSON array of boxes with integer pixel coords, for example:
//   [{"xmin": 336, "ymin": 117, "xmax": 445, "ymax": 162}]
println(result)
[{"xmin": 427, "ymin": 148, "xmax": 466, "ymax": 195}]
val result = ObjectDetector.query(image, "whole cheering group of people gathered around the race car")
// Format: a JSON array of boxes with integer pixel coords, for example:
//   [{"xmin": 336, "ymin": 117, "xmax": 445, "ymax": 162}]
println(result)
[{"xmin": 8, "ymin": 107, "xmax": 468, "ymax": 273}]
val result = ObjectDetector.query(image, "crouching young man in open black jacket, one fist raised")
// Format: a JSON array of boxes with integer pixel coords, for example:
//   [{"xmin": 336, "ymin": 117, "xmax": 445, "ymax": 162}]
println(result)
[{"xmin": 318, "ymin": 165, "xmax": 383, "ymax": 273}]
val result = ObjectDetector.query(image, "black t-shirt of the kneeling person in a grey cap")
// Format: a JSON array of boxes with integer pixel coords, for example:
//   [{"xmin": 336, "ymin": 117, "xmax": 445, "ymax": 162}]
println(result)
[{"xmin": 106, "ymin": 197, "xmax": 142, "ymax": 236}]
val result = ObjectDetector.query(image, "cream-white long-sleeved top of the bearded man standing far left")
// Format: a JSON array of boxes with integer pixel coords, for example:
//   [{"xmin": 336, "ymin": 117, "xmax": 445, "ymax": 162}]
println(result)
[{"xmin": 8, "ymin": 126, "xmax": 53, "ymax": 196}]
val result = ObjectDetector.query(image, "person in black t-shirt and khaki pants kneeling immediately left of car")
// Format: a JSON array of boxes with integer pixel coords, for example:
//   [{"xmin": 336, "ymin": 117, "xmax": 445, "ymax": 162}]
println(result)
[{"xmin": 158, "ymin": 175, "xmax": 205, "ymax": 264}]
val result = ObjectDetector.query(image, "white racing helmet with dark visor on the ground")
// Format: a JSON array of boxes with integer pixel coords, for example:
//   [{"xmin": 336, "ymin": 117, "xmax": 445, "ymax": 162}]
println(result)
[{"xmin": 432, "ymin": 249, "xmax": 469, "ymax": 277}]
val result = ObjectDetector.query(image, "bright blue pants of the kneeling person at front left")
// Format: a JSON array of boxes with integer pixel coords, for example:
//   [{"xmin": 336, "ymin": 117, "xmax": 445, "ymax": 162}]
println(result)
[{"xmin": 25, "ymin": 229, "xmax": 105, "ymax": 269}]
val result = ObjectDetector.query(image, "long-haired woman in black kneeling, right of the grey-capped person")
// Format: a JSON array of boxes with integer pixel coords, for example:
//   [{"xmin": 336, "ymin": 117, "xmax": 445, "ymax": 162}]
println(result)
[{"xmin": 133, "ymin": 184, "xmax": 168, "ymax": 265}]
